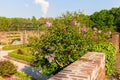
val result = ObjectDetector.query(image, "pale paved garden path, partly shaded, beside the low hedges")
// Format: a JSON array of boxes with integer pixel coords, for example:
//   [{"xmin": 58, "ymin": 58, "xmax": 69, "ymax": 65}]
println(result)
[{"xmin": 0, "ymin": 50, "xmax": 47, "ymax": 80}]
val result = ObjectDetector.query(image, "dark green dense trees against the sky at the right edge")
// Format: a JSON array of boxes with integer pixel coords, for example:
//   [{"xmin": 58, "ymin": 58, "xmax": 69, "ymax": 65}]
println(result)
[{"xmin": 90, "ymin": 7, "xmax": 120, "ymax": 32}]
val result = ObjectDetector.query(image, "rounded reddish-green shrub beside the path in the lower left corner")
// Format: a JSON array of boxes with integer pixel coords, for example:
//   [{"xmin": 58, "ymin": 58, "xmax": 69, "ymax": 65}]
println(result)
[{"xmin": 0, "ymin": 60, "xmax": 17, "ymax": 76}]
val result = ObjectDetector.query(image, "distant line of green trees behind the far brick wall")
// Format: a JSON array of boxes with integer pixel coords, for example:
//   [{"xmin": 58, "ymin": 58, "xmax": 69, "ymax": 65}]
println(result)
[{"xmin": 0, "ymin": 16, "xmax": 54, "ymax": 31}]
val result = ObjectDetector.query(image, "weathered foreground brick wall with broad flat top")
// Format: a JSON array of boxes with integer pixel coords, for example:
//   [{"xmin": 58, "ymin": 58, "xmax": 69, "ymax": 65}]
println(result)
[{"xmin": 48, "ymin": 52, "xmax": 105, "ymax": 80}]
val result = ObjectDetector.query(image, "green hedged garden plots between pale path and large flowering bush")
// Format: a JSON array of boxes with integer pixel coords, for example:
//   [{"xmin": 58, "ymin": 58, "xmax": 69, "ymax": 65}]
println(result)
[{"xmin": 3, "ymin": 44, "xmax": 34, "ymax": 63}]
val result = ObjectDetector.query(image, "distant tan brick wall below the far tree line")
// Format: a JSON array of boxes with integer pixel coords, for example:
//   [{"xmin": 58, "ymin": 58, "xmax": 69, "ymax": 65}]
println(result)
[{"xmin": 0, "ymin": 31, "xmax": 44, "ymax": 44}]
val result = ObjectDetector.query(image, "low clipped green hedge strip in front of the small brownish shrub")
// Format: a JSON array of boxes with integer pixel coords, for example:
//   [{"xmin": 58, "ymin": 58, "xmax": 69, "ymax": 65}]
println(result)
[{"xmin": 8, "ymin": 51, "xmax": 33, "ymax": 62}]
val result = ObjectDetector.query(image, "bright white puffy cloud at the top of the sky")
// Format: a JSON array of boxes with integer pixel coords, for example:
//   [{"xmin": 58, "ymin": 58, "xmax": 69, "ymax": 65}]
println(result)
[{"xmin": 35, "ymin": 0, "xmax": 49, "ymax": 16}]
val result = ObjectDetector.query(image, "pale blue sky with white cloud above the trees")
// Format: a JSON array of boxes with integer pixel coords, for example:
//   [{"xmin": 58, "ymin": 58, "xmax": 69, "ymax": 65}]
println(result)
[{"xmin": 0, "ymin": 0, "xmax": 120, "ymax": 18}]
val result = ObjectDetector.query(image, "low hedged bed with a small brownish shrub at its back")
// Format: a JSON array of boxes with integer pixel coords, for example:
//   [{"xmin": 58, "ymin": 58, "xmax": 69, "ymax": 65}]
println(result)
[{"xmin": 8, "ymin": 49, "xmax": 33, "ymax": 62}]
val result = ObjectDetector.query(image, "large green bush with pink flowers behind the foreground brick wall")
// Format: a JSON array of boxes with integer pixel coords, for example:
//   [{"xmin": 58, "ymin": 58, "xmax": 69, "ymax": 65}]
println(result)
[{"xmin": 30, "ymin": 20, "xmax": 113, "ymax": 74}]
